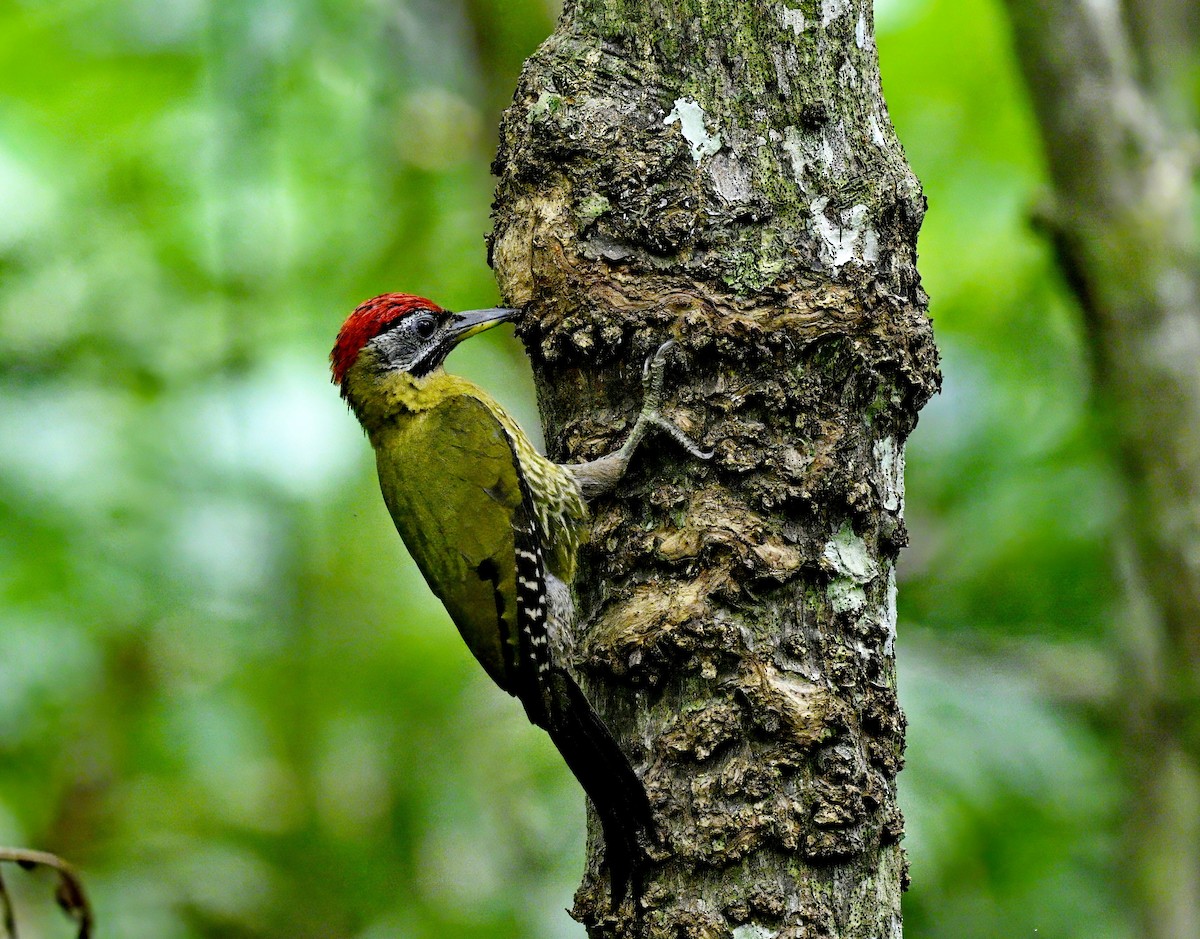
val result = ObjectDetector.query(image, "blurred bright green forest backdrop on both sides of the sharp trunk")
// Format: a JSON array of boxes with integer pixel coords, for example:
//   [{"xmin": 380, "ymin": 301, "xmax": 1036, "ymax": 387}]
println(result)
[{"xmin": 0, "ymin": 0, "xmax": 1183, "ymax": 939}]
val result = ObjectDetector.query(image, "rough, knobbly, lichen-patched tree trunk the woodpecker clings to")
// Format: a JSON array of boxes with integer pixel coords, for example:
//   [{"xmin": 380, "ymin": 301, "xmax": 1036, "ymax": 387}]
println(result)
[{"xmin": 492, "ymin": 0, "xmax": 938, "ymax": 939}]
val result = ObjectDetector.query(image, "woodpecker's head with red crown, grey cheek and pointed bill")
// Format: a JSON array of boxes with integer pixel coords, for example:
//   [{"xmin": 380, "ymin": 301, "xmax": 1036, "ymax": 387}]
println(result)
[{"xmin": 329, "ymin": 293, "xmax": 517, "ymax": 397}]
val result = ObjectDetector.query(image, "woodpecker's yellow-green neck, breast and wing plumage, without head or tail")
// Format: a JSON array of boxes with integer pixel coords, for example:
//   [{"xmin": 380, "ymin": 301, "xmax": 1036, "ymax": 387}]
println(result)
[{"xmin": 347, "ymin": 352, "xmax": 587, "ymax": 694}]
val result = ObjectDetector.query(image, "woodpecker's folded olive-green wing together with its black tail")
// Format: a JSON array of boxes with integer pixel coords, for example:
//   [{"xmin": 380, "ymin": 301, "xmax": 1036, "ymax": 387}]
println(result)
[{"xmin": 376, "ymin": 395, "xmax": 656, "ymax": 902}]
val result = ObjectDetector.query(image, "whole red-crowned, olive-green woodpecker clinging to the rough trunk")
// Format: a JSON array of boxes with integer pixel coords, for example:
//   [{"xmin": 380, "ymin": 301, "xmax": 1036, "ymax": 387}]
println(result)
[{"xmin": 330, "ymin": 293, "xmax": 712, "ymax": 905}]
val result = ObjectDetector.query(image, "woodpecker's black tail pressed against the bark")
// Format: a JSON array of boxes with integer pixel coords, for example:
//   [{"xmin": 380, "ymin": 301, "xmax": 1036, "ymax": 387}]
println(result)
[{"xmin": 546, "ymin": 669, "xmax": 658, "ymax": 909}]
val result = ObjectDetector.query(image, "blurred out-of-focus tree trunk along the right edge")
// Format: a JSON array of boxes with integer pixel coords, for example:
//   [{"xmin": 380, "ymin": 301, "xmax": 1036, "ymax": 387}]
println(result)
[{"xmin": 1008, "ymin": 0, "xmax": 1200, "ymax": 939}]
